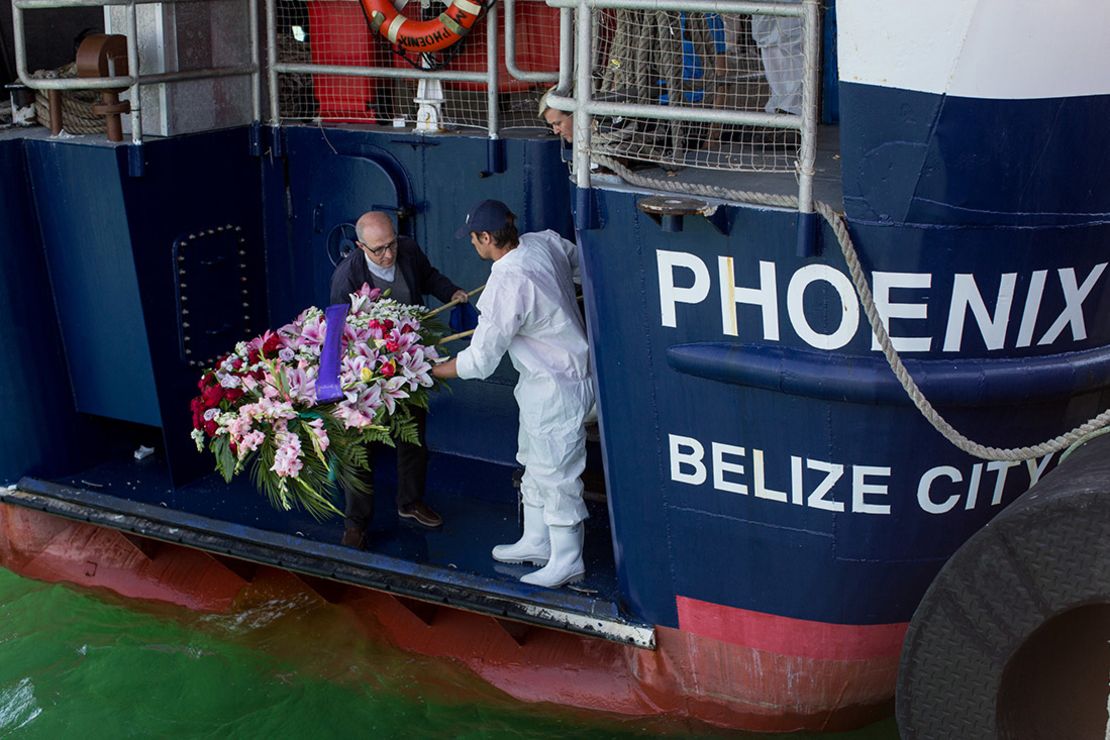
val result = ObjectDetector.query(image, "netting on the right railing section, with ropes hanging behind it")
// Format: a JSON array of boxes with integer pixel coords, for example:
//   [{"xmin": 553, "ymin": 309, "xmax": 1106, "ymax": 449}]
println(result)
[{"xmin": 591, "ymin": 10, "xmax": 805, "ymax": 172}]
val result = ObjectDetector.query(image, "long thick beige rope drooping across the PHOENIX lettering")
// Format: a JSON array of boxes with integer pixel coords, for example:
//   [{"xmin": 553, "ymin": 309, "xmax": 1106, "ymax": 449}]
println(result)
[{"xmin": 593, "ymin": 154, "xmax": 1110, "ymax": 462}]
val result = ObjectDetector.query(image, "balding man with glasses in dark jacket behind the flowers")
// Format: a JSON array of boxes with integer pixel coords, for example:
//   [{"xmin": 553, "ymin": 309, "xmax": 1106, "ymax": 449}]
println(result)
[{"xmin": 331, "ymin": 211, "xmax": 466, "ymax": 549}]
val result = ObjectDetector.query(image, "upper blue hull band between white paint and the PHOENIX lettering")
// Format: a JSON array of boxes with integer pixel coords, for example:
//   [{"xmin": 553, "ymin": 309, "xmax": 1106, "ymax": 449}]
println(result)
[{"xmin": 839, "ymin": 82, "xmax": 1110, "ymax": 227}]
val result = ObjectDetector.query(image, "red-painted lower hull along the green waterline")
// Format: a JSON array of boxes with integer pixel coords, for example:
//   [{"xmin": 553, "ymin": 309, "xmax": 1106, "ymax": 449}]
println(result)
[{"xmin": 0, "ymin": 505, "xmax": 906, "ymax": 731}]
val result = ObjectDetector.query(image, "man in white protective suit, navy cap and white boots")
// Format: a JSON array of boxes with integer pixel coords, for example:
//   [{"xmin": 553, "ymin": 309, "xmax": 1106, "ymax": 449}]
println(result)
[{"xmin": 432, "ymin": 201, "xmax": 594, "ymax": 588}]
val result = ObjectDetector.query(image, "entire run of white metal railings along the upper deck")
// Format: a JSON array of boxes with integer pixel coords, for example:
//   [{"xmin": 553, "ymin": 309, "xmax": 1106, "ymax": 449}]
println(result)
[{"xmin": 12, "ymin": 0, "xmax": 820, "ymax": 194}]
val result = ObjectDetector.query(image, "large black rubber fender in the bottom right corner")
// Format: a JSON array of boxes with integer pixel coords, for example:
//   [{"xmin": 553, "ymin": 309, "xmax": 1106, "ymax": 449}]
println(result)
[{"xmin": 896, "ymin": 434, "xmax": 1110, "ymax": 740}]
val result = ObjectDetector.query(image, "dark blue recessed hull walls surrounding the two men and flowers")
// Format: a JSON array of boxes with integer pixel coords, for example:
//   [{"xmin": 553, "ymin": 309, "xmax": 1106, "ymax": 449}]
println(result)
[{"xmin": 2, "ymin": 128, "xmax": 573, "ymax": 484}]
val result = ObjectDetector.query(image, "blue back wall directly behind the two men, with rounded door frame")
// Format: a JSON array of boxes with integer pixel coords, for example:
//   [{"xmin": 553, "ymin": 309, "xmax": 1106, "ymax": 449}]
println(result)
[{"xmin": 265, "ymin": 126, "xmax": 573, "ymax": 464}]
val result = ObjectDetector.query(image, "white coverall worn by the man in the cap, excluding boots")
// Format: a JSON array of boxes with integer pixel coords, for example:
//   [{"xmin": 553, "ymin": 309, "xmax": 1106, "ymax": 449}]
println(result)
[{"xmin": 456, "ymin": 231, "xmax": 594, "ymax": 527}]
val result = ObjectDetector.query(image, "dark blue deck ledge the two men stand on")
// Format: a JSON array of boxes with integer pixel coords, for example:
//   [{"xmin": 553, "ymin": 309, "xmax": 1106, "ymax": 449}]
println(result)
[{"xmin": 0, "ymin": 439, "xmax": 655, "ymax": 648}]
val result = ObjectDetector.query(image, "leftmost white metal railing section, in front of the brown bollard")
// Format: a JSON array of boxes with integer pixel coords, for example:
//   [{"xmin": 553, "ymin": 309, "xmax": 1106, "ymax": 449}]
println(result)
[{"xmin": 11, "ymin": 0, "xmax": 262, "ymax": 145}]
